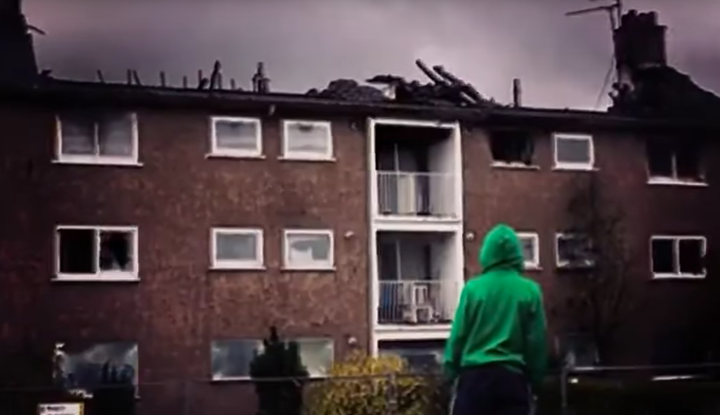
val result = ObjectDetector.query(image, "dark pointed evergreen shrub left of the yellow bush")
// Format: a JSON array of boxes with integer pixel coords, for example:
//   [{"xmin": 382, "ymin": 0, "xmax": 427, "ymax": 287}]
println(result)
[{"xmin": 250, "ymin": 327, "xmax": 308, "ymax": 415}]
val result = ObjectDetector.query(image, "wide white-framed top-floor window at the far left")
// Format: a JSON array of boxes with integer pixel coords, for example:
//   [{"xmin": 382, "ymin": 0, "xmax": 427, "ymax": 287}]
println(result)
[{"xmin": 57, "ymin": 113, "xmax": 138, "ymax": 164}]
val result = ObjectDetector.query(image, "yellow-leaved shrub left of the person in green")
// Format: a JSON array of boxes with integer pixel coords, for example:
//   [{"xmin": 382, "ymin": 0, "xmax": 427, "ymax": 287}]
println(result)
[{"xmin": 308, "ymin": 353, "xmax": 437, "ymax": 415}]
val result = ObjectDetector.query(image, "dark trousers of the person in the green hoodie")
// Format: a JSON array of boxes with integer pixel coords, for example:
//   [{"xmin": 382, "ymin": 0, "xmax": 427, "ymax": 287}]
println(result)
[{"xmin": 452, "ymin": 364, "xmax": 533, "ymax": 415}]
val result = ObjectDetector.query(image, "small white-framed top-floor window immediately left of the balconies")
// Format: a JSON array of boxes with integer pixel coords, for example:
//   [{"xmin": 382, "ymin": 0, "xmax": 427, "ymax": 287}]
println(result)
[{"xmin": 283, "ymin": 120, "xmax": 333, "ymax": 160}]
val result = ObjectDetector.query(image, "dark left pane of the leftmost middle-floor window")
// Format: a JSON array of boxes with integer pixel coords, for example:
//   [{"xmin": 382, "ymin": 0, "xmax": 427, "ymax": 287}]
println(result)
[{"xmin": 58, "ymin": 229, "xmax": 96, "ymax": 274}]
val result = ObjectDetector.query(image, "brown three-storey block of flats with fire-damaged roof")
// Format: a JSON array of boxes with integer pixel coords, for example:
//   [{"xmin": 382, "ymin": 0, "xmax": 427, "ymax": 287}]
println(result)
[{"xmin": 0, "ymin": 4, "xmax": 720, "ymax": 411}]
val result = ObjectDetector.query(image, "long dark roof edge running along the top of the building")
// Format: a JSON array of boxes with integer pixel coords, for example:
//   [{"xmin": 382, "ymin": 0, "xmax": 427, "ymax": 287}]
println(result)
[{"xmin": 0, "ymin": 80, "xmax": 720, "ymax": 130}]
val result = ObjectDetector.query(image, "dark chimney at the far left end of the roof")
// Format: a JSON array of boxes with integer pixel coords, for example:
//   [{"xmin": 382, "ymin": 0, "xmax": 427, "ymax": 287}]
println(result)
[{"xmin": 0, "ymin": 0, "xmax": 38, "ymax": 85}]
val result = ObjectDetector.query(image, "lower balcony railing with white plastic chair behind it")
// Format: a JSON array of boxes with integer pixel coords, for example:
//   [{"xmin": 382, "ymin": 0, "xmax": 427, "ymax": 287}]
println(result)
[{"xmin": 377, "ymin": 280, "xmax": 458, "ymax": 325}]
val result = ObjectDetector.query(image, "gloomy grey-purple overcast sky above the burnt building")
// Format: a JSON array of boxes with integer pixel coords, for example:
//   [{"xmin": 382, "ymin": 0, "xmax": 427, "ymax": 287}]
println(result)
[{"xmin": 23, "ymin": 0, "xmax": 720, "ymax": 109}]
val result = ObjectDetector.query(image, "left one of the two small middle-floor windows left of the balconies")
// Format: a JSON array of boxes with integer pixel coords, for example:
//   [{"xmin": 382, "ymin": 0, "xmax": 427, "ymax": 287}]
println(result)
[{"xmin": 211, "ymin": 228, "xmax": 263, "ymax": 269}]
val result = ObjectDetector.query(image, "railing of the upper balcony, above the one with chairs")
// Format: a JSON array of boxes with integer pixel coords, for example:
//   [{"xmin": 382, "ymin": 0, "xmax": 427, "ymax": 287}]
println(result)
[{"xmin": 377, "ymin": 171, "xmax": 457, "ymax": 218}]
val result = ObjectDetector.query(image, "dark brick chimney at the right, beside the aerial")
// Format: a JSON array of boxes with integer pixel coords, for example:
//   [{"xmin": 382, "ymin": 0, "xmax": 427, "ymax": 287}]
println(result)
[{"xmin": 613, "ymin": 10, "xmax": 667, "ymax": 85}]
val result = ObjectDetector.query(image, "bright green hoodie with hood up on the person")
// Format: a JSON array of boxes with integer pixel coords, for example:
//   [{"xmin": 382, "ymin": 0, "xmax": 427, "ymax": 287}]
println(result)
[{"xmin": 445, "ymin": 224, "xmax": 547, "ymax": 387}]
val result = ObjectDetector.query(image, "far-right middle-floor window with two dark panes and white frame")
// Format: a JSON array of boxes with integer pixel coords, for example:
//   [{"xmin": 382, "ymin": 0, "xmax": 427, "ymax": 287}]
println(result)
[{"xmin": 650, "ymin": 236, "xmax": 707, "ymax": 278}]
